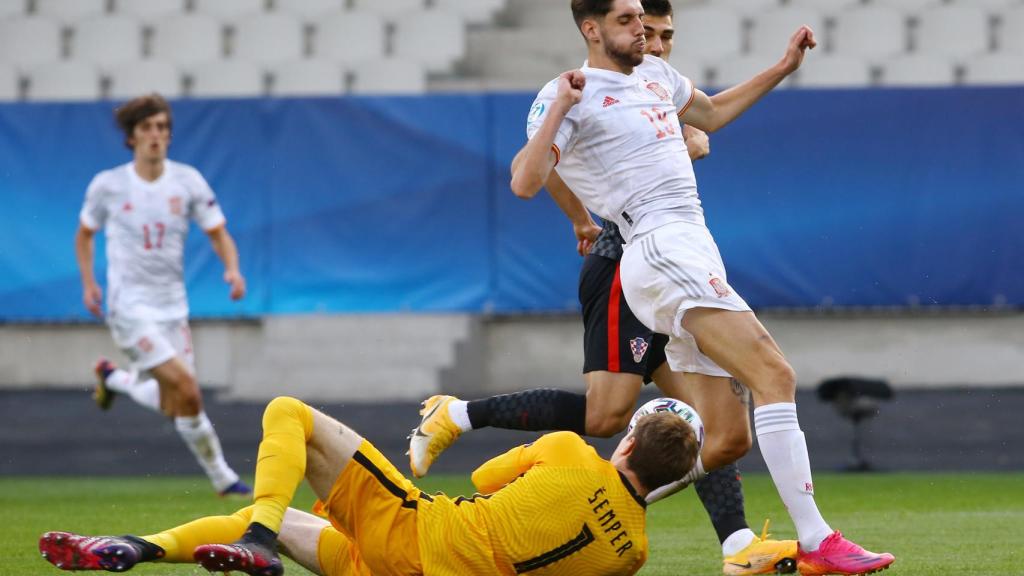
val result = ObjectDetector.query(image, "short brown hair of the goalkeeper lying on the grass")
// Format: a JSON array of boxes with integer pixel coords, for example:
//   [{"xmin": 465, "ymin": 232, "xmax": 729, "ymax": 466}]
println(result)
[{"xmin": 626, "ymin": 412, "xmax": 700, "ymax": 490}]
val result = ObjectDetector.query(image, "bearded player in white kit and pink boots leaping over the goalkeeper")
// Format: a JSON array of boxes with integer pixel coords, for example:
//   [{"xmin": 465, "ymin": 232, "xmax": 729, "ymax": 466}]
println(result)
[{"xmin": 511, "ymin": 0, "xmax": 894, "ymax": 576}]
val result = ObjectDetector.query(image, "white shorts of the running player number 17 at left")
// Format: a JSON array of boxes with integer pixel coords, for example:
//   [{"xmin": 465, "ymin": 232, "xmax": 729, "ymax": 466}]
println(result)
[{"xmin": 106, "ymin": 317, "xmax": 196, "ymax": 373}]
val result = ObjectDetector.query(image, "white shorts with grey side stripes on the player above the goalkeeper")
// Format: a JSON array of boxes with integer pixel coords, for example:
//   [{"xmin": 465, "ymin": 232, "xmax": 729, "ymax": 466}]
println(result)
[{"xmin": 620, "ymin": 222, "xmax": 751, "ymax": 377}]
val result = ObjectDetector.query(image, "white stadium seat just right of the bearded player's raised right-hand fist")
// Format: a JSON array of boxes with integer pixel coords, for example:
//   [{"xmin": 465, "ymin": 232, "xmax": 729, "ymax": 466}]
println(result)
[{"xmin": 831, "ymin": 6, "xmax": 908, "ymax": 61}]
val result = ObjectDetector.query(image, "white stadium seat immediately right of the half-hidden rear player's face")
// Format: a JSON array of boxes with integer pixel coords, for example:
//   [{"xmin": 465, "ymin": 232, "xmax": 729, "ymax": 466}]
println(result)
[{"xmin": 673, "ymin": 6, "xmax": 743, "ymax": 59}]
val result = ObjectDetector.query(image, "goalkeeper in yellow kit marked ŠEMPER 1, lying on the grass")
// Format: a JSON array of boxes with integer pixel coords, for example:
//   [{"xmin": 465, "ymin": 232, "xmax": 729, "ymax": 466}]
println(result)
[{"xmin": 40, "ymin": 391, "xmax": 697, "ymax": 576}]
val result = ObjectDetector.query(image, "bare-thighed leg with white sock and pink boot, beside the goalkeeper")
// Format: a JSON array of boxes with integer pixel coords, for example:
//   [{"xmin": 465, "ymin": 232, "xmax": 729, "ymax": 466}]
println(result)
[{"xmin": 682, "ymin": 307, "xmax": 893, "ymax": 574}]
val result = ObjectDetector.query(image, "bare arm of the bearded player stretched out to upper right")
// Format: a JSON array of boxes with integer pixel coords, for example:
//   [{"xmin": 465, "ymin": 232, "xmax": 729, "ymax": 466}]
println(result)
[{"xmin": 681, "ymin": 26, "xmax": 817, "ymax": 132}]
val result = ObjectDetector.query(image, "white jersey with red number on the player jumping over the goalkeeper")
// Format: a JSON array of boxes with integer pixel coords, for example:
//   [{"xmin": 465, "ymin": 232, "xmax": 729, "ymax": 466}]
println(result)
[{"xmin": 526, "ymin": 55, "xmax": 705, "ymax": 242}]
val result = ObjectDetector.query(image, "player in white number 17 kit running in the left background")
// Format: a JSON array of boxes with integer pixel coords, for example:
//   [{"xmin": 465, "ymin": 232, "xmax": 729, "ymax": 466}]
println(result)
[{"xmin": 75, "ymin": 94, "xmax": 252, "ymax": 496}]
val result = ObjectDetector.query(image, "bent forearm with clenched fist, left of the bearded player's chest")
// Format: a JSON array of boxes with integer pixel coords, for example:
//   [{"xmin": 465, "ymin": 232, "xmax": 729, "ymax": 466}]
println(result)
[{"xmin": 512, "ymin": 70, "xmax": 587, "ymax": 198}]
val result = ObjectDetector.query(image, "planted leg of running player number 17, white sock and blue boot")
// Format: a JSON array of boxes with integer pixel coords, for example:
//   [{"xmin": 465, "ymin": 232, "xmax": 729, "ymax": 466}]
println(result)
[{"xmin": 150, "ymin": 358, "xmax": 251, "ymax": 497}]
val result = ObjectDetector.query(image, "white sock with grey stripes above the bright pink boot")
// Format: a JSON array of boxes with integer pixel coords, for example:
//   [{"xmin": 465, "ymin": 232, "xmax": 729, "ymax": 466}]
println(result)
[{"xmin": 754, "ymin": 402, "xmax": 833, "ymax": 552}]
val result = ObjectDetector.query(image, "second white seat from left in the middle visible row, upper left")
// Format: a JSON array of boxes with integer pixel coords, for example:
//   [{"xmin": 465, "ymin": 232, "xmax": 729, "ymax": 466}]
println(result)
[{"xmin": 71, "ymin": 15, "xmax": 142, "ymax": 68}]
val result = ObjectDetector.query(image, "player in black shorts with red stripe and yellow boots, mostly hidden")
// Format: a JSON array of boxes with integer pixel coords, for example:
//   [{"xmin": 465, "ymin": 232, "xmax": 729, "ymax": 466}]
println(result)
[{"xmin": 411, "ymin": 0, "xmax": 797, "ymax": 575}]
